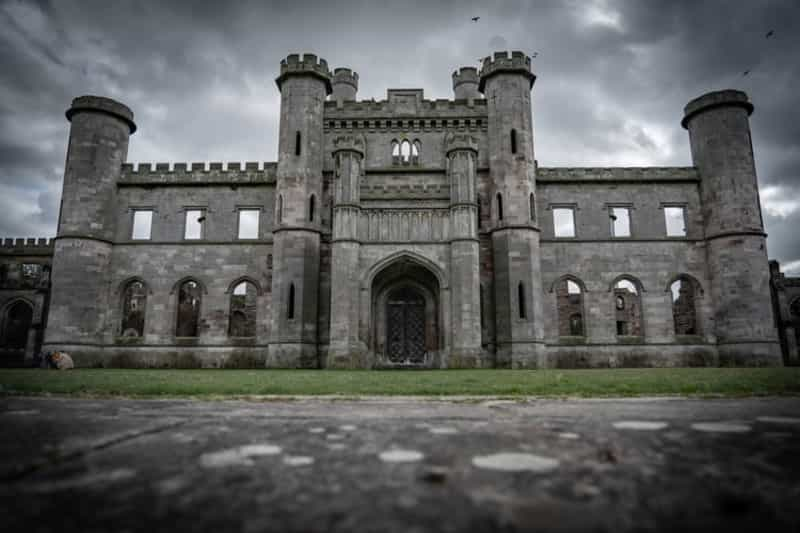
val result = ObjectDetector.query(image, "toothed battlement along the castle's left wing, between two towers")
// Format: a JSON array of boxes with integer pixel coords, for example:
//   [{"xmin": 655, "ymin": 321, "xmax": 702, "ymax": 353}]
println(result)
[{"xmin": 119, "ymin": 161, "xmax": 277, "ymax": 185}]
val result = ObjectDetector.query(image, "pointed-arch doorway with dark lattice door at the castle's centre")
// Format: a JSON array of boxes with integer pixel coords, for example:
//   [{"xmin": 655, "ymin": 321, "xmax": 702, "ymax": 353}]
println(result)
[{"xmin": 368, "ymin": 256, "xmax": 443, "ymax": 367}]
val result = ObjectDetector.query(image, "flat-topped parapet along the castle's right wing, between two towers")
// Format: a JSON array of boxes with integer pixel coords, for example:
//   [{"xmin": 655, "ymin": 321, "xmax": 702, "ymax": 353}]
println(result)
[{"xmin": 536, "ymin": 167, "xmax": 700, "ymax": 184}]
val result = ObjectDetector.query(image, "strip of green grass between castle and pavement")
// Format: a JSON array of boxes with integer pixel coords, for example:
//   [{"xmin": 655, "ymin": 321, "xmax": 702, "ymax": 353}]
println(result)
[{"xmin": 0, "ymin": 368, "xmax": 800, "ymax": 398}]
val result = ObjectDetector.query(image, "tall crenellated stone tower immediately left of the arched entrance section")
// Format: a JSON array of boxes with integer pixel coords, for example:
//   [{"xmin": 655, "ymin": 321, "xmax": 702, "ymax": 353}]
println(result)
[{"xmin": 268, "ymin": 54, "xmax": 332, "ymax": 368}]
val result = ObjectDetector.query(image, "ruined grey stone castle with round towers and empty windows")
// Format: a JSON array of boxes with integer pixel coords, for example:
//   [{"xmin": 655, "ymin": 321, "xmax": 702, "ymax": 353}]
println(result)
[{"xmin": 0, "ymin": 52, "xmax": 800, "ymax": 368}]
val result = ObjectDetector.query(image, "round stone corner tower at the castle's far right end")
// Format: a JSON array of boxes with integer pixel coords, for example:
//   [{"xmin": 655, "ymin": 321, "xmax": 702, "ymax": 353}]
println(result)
[{"xmin": 681, "ymin": 90, "xmax": 781, "ymax": 365}]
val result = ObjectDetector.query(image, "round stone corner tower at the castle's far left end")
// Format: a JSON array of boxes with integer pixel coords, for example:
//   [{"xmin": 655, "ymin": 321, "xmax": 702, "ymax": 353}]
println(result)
[{"xmin": 43, "ymin": 96, "xmax": 136, "ymax": 364}]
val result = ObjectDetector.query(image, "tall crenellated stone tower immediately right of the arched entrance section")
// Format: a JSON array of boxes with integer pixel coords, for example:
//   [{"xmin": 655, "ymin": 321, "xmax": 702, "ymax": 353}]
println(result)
[{"xmin": 478, "ymin": 52, "xmax": 545, "ymax": 368}]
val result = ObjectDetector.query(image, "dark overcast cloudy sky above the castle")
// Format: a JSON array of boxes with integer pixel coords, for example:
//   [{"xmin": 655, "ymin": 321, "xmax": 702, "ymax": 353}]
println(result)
[{"xmin": 0, "ymin": 0, "xmax": 800, "ymax": 274}]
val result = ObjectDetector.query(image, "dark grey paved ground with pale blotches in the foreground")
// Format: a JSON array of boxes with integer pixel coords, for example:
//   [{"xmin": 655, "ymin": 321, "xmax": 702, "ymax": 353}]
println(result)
[{"xmin": 0, "ymin": 398, "xmax": 800, "ymax": 533}]
